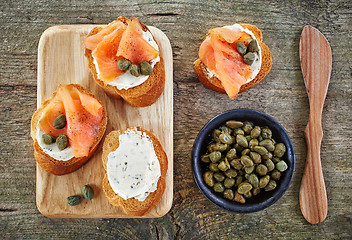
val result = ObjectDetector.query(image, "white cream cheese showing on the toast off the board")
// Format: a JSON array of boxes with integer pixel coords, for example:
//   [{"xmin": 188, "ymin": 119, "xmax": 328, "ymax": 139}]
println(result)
[{"xmin": 206, "ymin": 24, "xmax": 262, "ymax": 83}]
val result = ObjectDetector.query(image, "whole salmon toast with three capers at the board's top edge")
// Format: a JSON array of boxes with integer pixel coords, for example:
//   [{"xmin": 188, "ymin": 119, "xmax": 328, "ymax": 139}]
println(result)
[{"xmin": 84, "ymin": 16, "xmax": 165, "ymax": 107}]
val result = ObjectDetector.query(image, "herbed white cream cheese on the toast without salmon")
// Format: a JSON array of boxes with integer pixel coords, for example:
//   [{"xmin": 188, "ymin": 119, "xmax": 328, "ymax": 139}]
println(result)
[{"xmin": 107, "ymin": 129, "xmax": 161, "ymax": 201}]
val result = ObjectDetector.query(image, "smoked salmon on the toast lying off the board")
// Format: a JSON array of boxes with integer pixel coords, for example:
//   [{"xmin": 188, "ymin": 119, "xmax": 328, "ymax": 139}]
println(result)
[{"xmin": 198, "ymin": 25, "xmax": 253, "ymax": 99}]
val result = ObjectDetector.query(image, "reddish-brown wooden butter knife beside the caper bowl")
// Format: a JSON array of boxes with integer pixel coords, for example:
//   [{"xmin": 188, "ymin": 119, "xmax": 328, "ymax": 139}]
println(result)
[{"xmin": 299, "ymin": 26, "xmax": 332, "ymax": 224}]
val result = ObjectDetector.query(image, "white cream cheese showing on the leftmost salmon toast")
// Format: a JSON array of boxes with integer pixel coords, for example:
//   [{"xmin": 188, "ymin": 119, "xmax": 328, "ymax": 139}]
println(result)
[{"xmin": 36, "ymin": 127, "xmax": 74, "ymax": 161}]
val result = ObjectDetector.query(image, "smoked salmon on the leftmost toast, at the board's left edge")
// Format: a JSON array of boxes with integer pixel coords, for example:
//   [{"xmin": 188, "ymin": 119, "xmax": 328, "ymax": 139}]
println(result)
[{"xmin": 39, "ymin": 85, "xmax": 103, "ymax": 158}]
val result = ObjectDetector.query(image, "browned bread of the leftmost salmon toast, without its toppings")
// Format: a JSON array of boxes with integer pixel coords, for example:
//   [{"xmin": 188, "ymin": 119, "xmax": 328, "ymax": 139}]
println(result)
[{"xmin": 31, "ymin": 84, "xmax": 107, "ymax": 176}]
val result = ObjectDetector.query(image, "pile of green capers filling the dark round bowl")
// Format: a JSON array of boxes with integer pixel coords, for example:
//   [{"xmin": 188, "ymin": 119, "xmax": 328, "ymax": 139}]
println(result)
[{"xmin": 201, "ymin": 120, "xmax": 288, "ymax": 203}]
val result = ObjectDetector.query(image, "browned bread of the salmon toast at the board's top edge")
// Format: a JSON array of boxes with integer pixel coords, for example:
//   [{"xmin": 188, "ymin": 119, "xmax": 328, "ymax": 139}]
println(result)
[{"xmin": 84, "ymin": 16, "xmax": 165, "ymax": 107}]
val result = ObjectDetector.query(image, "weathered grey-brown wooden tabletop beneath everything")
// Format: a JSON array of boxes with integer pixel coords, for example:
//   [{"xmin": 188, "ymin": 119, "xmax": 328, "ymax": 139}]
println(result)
[{"xmin": 0, "ymin": 0, "xmax": 352, "ymax": 239}]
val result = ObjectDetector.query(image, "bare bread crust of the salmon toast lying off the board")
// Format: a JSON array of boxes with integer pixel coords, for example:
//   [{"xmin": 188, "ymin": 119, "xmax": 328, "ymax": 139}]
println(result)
[{"xmin": 194, "ymin": 24, "xmax": 273, "ymax": 94}]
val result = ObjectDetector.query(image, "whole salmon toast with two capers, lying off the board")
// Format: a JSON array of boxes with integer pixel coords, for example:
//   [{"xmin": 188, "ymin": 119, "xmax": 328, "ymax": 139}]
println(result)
[{"xmin": 194, "ymin": 24, "xmax": 272, "ymax": 99}]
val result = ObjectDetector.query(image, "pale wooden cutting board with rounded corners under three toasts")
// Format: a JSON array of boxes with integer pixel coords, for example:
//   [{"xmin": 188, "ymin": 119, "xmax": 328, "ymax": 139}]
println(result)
[{"xmin": 36, "ymin": 25, "xmax": 173, "ymax": 218}]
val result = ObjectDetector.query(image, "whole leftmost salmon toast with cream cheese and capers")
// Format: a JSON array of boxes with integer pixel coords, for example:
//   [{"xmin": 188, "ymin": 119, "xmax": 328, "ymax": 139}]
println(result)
[{"xmin": 31, "ymin": 84, "xmax": 107, "ymax": 175}]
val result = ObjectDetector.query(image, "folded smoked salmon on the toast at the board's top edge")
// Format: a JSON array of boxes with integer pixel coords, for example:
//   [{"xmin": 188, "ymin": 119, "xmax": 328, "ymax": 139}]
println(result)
[{"xmin": 84, "ymin": 18, "xmax": 159, "ymax": 84}]
